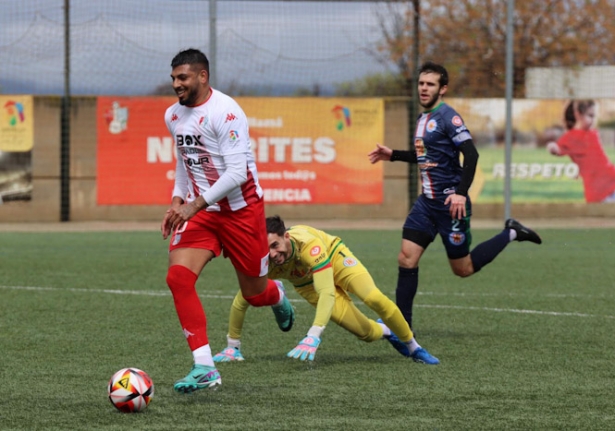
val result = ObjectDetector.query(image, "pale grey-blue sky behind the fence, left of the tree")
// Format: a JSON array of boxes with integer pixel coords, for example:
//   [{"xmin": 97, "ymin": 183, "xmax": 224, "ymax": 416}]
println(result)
[{"xmin": 0, "ymin": 0, "xmax": 398, "ymax": 95}]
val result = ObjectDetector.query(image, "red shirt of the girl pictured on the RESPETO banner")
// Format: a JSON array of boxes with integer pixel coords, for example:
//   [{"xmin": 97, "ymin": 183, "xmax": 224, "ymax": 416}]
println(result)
[{"xmin": 557, "ymin": 129, "xmax": 615, "ymax": 202}]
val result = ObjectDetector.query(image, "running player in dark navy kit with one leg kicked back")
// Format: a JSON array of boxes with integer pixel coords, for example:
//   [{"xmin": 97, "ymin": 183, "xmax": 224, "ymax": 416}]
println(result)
[{"xmin": 368, "ymin": 62, "xmax": 542, "ymax": 327}]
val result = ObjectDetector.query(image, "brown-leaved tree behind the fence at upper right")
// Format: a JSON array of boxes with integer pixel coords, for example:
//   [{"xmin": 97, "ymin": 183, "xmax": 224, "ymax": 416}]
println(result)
[{"xmin": 378, "ymin": 0, "xmax": 615, "ymax": 97}]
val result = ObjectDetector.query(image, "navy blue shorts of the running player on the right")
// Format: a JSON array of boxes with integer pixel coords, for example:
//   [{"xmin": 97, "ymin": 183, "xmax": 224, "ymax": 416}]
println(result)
[{"xmin": 404, "ymin": 195, "xmax": 472, "ymax": 259}]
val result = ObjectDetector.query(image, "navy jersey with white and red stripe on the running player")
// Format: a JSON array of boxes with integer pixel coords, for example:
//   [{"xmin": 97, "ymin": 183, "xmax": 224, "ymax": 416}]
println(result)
[{"xmin": 414, "ymin": 102, "xmax": 472, "ymax": 200}]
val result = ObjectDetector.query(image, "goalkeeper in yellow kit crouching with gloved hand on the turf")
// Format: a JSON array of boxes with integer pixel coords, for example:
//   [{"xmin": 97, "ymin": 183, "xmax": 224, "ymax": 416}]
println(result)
[{"xmin": 214, "ymin": 216, "xmax": 440, "ymax": 365}]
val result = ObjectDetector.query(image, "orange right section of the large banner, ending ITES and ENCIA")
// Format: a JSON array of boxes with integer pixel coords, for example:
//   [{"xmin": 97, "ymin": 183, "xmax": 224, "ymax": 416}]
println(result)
[{"xmin": 237, "ymin": 98, "xmax": 384, "ymax": 204}]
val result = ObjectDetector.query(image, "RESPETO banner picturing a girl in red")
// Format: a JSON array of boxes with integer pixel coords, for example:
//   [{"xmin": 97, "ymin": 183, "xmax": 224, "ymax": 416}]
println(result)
[{"xmin": 447, "ymin": 99, "xmax": 615, "ymax": 203}]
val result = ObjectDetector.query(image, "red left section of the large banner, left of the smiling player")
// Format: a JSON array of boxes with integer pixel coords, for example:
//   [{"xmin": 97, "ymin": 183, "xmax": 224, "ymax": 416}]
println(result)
[{"xmin": 96, "ymin": 97, "xmax": 177, "ymax": 205}]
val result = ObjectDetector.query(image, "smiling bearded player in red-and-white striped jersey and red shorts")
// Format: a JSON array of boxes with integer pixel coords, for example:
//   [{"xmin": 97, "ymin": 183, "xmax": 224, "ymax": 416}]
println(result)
[{"xmin": 161, "ymin": 49, "xmax": 294, "ymax": 393}]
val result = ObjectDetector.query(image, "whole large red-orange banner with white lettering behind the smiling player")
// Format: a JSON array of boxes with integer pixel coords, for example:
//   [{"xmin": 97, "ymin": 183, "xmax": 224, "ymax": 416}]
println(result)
[{"xmin": 97, "ymin": 97, "xmax": 384, "ymax": 205}]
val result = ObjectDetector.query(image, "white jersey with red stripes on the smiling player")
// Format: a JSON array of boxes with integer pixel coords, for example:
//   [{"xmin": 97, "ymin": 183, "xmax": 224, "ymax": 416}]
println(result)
[{"xmin": 164, "ymin": 89, "xmax": 263, "ymax": 211}]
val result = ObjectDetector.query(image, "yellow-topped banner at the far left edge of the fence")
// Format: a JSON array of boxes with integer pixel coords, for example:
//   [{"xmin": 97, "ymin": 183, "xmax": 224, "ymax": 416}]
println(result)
[{"xmin": 0, "ymin": 96, "xmax": 34, "ymax": 204}]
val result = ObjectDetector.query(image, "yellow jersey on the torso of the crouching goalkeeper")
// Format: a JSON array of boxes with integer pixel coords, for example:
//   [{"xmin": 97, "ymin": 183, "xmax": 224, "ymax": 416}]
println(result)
[{"xmin": 269, "ymin": 225, "xmax": 342, "ymax": 288}]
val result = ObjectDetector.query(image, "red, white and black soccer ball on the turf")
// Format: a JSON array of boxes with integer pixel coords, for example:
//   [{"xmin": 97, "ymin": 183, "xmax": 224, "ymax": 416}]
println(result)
[{"xmin": 108, "ymin": 368, "xmax": 154, "ymax": 413}]
